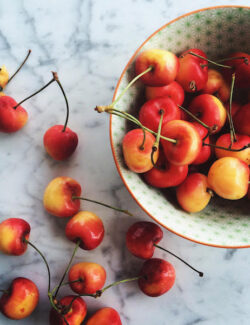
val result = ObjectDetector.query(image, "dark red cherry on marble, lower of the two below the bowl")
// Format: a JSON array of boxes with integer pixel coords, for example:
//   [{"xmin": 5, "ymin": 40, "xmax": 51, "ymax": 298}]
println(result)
[{"xmin": 138, "ymin": 258, "xmax": 175, "ymax": 297}]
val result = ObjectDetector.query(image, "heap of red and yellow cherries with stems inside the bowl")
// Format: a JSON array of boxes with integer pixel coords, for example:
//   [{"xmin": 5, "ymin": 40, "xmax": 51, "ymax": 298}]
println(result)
[{"xmin": 95, "ymin": 48, "xmax": 250, "ymax": 212}]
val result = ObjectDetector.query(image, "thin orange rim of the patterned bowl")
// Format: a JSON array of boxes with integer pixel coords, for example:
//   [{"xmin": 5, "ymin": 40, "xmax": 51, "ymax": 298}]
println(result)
[{"xmin": 109, "ymin": 5, "xmax": 250, "ymax": 248}]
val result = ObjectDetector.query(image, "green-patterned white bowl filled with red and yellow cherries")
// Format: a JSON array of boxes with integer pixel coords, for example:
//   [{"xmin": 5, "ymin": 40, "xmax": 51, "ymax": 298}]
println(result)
[{"xmin": 96, "ymin": 6, "xmax": 250, "ymax": 248}]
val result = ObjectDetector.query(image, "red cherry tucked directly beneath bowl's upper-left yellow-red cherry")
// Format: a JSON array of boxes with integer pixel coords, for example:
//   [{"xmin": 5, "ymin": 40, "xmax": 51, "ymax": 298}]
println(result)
[{"xmin": 145, "ymin": 81, "xmax": 185, "ymax": 105}]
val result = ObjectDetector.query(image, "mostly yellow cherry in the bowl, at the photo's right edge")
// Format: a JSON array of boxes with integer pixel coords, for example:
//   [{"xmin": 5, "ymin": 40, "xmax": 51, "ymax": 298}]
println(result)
[{"xmin": 208, "ymin": 157, "xmax": 249, "ymax": 200}]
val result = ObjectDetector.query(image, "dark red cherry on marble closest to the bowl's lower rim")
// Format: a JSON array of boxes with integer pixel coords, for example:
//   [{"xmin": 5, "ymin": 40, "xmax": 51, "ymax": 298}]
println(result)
[{"xmin": 126, "ymin": 221, "xmax": 163, "ymax": 259}]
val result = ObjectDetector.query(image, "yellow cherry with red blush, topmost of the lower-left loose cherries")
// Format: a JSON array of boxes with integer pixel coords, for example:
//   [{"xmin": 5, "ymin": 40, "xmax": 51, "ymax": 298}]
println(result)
[{"xmin": 43, "ymin": 176, "xmax": 82, "ymax": 218}]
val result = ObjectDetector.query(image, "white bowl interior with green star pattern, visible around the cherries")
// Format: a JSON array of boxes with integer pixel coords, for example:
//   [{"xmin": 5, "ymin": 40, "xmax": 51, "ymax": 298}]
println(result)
[{"xmin": 110, "ymin": 7, "xmax": 250, "ymax": 247}]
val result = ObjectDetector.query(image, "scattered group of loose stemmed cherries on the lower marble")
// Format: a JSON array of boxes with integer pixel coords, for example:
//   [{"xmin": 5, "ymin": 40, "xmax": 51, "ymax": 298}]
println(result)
[{"xmin": 0, "ymin": 177, "xmax": 203, "ymax": 325}]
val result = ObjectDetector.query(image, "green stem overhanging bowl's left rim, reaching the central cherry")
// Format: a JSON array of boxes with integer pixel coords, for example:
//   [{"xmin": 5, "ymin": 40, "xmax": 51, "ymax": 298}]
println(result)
[{"xmin": 95, "ymin": 106, "xmax": 177, "ymax": 143}]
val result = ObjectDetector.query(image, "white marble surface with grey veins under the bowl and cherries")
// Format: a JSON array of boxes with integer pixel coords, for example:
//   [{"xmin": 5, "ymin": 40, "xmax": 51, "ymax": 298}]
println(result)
[{"xmin": 0, "ymin": 0, "xmax": 250, "ymax": 325}]
